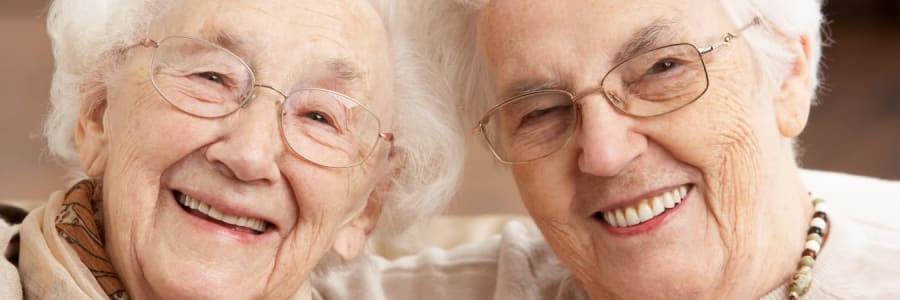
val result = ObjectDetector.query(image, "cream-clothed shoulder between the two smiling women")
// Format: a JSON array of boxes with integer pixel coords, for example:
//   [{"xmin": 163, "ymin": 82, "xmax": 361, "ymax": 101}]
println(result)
[{"xmin": 314, "ymin": 221, "xmax": 584, "ymax": 300}]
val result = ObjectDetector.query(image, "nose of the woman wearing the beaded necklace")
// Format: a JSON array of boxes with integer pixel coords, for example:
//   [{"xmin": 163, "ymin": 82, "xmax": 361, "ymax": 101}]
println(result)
[{"xmin": 575, "ymin": 94, "xmax": 647, "ymax": 177}]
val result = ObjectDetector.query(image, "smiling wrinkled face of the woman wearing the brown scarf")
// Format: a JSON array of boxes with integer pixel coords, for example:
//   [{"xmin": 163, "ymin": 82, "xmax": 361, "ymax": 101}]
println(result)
[{"xmin": 77, "ymin": 1, "xmax": 392, "ymax": 299}]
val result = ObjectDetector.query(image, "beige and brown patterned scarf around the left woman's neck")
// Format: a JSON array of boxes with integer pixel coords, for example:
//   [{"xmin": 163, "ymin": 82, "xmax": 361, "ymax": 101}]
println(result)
[{"xmin": 19, "ymin": 180, "xmax": 128, "ymax": 299}]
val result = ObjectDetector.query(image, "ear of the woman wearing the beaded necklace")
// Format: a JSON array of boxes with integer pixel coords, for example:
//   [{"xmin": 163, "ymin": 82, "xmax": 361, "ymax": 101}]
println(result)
[{"xmin": 775, "ymin": 36, "xmax": 813, "ymax": 138}]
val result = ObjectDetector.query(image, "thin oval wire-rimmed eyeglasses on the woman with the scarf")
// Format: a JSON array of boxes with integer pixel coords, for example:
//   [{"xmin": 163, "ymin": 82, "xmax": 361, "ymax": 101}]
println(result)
[{"xmin": 135, "ymin": 36, "xmax": 394, "ymax": 168}]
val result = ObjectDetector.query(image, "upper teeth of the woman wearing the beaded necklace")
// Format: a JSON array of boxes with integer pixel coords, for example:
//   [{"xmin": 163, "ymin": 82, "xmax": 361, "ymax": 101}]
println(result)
[{"xmin": 603, "ymin": 185, "xmax": 687, "ymax": 227}]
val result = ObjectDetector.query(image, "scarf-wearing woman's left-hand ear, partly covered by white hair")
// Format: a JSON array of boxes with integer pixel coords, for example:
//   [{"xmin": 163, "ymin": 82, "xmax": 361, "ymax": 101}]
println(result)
[{"xmin": 75, "ymin": 92, "xmax": 108, "ymax": 177}]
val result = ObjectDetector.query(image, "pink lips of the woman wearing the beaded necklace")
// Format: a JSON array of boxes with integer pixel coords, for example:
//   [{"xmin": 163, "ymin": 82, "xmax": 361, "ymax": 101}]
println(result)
[{"xmin": 591, "ymin": 184, "xmax": 695, "ymax": 237}]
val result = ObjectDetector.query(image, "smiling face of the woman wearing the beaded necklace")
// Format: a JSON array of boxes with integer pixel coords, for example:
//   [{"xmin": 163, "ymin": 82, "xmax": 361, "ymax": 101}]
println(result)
[{"xmin": 477, "ymin": 0, "xmax": 809, "ymax": 299}]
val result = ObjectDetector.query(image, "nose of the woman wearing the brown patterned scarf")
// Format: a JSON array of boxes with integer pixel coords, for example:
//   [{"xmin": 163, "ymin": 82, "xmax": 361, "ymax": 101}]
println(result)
[{"xmin": 206, "ymin": 89, "xmax": 284, "ymax": 182}]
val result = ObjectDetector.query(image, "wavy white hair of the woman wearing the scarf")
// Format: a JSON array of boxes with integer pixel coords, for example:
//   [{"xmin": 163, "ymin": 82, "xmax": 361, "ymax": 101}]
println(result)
[{"xmin": 44, "ymin": 0, "xmax": 465, "ymax": 239}]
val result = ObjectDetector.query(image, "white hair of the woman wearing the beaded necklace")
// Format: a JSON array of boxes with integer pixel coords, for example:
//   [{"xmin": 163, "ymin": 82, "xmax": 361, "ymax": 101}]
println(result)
[{"xmin": 410, "ymin": 0, "xmax": 823, "ymax": 126}]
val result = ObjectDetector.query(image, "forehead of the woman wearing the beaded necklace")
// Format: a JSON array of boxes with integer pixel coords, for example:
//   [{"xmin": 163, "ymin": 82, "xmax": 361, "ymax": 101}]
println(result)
[{"xmin": 477, "ymin": 0, "xmax": 728, "ymax": 93}]
